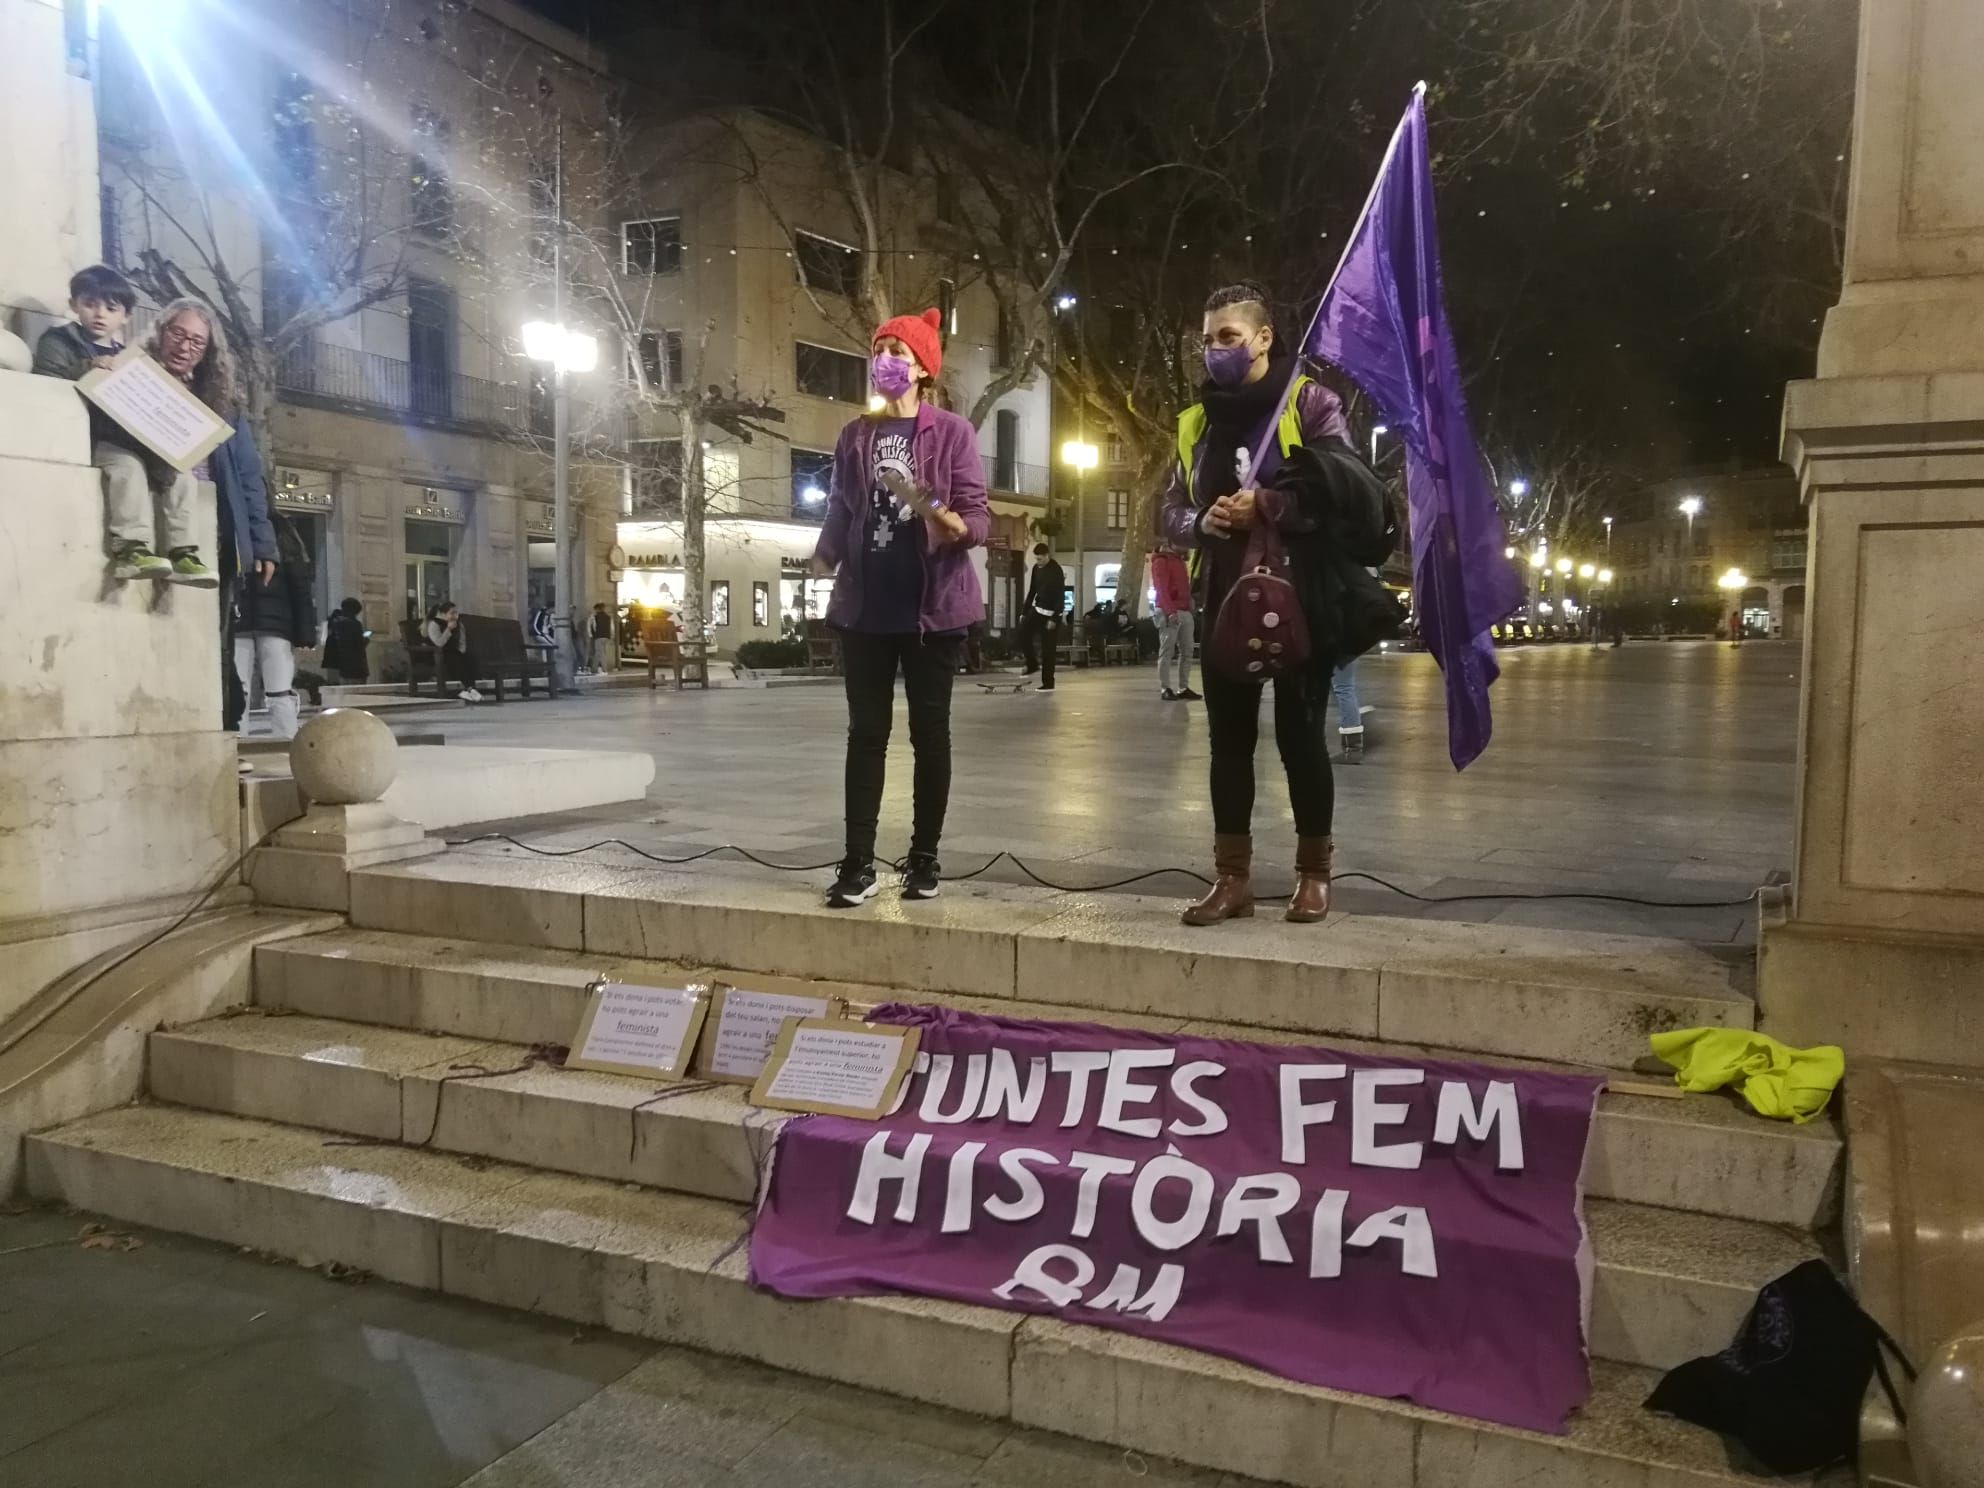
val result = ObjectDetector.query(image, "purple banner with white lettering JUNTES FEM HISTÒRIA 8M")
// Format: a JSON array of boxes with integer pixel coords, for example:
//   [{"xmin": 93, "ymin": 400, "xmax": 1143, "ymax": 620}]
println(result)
[{"xmin": 750, "ymin": 1006, "xmax": 1603, "ymax": 1432}]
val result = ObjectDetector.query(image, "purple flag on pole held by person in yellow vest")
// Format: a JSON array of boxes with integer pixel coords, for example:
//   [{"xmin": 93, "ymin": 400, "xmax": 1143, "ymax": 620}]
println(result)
[{"xmin": 1303, "ymin": 85, "xmax": 1522, "ymax": 770}]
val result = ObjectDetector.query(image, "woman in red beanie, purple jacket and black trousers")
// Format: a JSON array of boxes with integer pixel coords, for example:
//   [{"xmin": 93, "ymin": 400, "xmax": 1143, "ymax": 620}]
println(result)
[{"xmin": 813, "ymin": 310, "xmax": 990, "ymax": 909}]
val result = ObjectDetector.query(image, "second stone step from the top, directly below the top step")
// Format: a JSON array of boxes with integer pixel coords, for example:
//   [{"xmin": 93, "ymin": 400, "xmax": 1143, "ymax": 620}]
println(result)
[{"xmin": 256, "ymin": 929, "xmax": 1841, "ymax": 1230}]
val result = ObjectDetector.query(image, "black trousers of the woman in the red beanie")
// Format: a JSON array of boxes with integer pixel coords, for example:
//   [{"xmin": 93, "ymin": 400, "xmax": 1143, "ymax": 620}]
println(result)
[{"xmin": 841, "ymin": 631, "xmax": 964, "ymax": 861}]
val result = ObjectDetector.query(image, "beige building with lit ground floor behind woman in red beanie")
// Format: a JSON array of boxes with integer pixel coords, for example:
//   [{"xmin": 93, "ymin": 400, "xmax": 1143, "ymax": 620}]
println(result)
[{"xmin": 615, "ymin": 109, "xmax": 1052, "ymax": 653}]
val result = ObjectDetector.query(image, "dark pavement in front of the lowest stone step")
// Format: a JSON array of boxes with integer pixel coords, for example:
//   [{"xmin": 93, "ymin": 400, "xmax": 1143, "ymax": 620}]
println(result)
[{"xmin": 0, "ymin": 1208, "xmax": 1252, "ymax": 1488}]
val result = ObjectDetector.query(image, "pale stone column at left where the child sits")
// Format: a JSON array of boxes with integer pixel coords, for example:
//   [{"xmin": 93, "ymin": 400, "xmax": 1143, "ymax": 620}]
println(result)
[{"xmin": 0, "ymin": 0, "xmax": 240, "ymax": 1020}]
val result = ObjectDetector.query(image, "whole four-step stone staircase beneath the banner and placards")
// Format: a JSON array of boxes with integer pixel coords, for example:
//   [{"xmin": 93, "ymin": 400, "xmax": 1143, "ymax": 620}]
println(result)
[{"xmin": 26, "ymin": 851, "xmax": 1841, "ymax": 1488}]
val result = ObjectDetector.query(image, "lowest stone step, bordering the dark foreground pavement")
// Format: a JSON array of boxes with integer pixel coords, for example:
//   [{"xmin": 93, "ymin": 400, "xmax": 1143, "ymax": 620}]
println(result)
[{"xmin": 28, "ymin": 1107, "xmax": 1825, "ymax": 1488}]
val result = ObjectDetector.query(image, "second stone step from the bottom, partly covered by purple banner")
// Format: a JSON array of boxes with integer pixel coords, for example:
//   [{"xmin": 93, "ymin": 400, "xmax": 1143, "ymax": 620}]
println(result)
[{"xmin": 151, "ymin": 1014, "xmax": 1815, "ymax": 1369}]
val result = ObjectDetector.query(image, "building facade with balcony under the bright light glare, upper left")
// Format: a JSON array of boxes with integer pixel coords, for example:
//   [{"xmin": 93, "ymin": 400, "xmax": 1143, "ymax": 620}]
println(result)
[{"xmin": 97, "ymin": 0, "xmax": 621, "ymax": 677}]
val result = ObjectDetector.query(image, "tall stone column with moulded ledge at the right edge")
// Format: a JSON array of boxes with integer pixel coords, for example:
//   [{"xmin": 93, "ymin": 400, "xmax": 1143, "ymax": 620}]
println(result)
[{"xmin": 1760, "ymin": 0, "xmax": 1984, "ymax": 1065}]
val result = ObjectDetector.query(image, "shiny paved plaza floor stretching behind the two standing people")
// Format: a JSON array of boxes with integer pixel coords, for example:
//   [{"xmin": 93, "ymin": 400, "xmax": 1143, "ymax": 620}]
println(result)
[{"xmin": 391, "ymin": 641, "xmax": 1799, "ymax": 944}]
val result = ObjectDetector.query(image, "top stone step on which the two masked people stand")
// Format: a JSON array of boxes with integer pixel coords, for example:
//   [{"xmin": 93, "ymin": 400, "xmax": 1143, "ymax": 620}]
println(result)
[{"xmin": 337, "ymin": 845, "xmax": 1756, "ymax": 1069}]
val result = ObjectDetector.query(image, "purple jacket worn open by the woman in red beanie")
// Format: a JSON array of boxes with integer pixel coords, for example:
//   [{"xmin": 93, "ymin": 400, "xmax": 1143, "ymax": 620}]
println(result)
[{"xmin": 813, "ymin": 403, "xmax": 992, "ymax": 631}]
